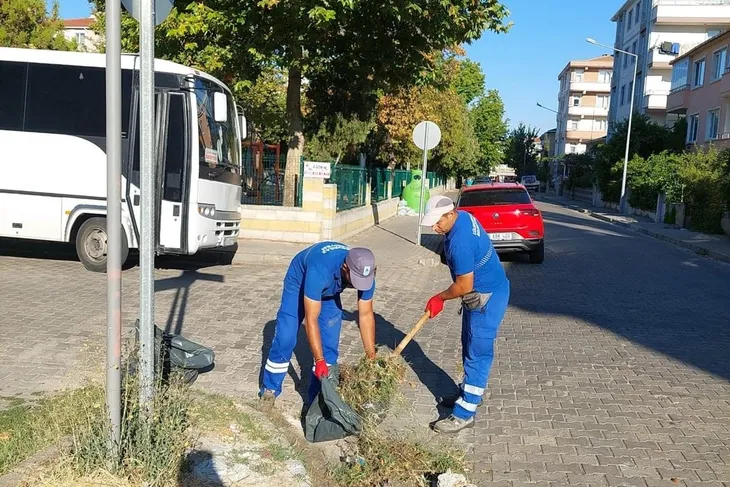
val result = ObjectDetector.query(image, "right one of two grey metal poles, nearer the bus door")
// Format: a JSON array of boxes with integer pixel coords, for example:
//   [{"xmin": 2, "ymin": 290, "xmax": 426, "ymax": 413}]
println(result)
[{"xmin": 139, "ymin": 0, "xmax": 157, "ymax": 416}]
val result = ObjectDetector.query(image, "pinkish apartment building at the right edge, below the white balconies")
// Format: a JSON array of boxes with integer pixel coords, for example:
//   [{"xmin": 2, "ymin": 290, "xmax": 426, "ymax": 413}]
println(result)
[{"xmin": 667, "ymin": 31, "xmax": 730, "ymax": 147}]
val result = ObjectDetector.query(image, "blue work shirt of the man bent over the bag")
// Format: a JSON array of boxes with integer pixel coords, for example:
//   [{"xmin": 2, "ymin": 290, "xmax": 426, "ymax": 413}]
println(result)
[{"xmin": 284, "ymin": 242, "xmax": 375, "ymax": 301}]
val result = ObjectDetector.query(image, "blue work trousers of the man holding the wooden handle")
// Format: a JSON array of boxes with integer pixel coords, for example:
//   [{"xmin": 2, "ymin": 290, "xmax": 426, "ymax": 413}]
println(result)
[{"xmin": 453, "ymin": 283, "xmax": 509, "ymax": 419}]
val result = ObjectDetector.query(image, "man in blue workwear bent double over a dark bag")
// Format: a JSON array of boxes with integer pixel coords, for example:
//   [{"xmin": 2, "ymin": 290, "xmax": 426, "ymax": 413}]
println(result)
[{"xmin": 259, "ymin": 242, "xmax": 375, "ymax": 410}]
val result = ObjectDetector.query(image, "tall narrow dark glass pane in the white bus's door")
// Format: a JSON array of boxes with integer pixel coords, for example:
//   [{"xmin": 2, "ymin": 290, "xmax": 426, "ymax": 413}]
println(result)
[{"xmin": 162, "ymin": 95, "xmax": 187, "ymax": 203}]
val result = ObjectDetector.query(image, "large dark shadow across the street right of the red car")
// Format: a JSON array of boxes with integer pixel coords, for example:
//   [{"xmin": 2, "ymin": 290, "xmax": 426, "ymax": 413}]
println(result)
[{"xmin": 506, "ymin": 204, "xmax": 730, "ymax": 385}]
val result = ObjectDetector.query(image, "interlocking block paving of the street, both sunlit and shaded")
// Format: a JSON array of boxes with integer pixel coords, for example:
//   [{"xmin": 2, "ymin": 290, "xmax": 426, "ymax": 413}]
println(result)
[{"xmin": 0, "ymin": 200, "xmax": 730, "ymax": 487}]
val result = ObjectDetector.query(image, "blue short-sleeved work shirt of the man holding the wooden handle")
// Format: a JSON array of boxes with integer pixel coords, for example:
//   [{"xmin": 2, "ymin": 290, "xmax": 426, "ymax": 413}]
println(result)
[{"xmin": 444, "ymin": 210, "xmax": 508, "ymax": 293}]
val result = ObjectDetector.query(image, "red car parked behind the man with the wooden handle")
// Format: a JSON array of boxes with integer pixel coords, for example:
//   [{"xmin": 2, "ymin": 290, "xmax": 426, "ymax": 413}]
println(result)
[{"xmin": 456, "ymin": 183, "xmax": 545, "ymax": 264}]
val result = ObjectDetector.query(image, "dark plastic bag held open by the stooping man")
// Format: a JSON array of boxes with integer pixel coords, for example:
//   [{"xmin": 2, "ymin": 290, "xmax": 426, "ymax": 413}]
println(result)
[{"xmin": 304, "ymin": 365, "xmax": 362, "ymax": 443}]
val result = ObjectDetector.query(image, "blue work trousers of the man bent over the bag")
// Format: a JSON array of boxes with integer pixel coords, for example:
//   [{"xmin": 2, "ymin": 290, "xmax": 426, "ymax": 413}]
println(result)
[{"xmin": 261, "ymin": 288, "xmax": 342, "ymax": 404}]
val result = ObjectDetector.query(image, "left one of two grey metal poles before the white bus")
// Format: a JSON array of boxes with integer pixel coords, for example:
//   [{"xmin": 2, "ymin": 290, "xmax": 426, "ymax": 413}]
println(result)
[{"xmin": 106, "ymin": 1, "xmax": 122, "ymax": 461}]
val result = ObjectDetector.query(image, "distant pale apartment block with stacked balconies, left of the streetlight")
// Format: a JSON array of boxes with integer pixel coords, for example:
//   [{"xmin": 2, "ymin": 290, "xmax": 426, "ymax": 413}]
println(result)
[{"xmin": 555, "ymin": 55, "xmax": 613, "ymax": 155}]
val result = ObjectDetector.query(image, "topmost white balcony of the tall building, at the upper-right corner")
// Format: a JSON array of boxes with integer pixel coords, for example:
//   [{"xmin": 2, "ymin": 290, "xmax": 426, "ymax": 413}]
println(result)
[{"xmin": 652, "ymin": 0, "xmax": 730, "ymax": 25}]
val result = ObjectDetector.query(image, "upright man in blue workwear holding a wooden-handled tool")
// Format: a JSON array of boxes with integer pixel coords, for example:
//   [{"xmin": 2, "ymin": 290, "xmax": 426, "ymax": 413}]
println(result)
[{"xmin": 421, "ymin": 196, "xmax": 510, "ymax": 433}]
